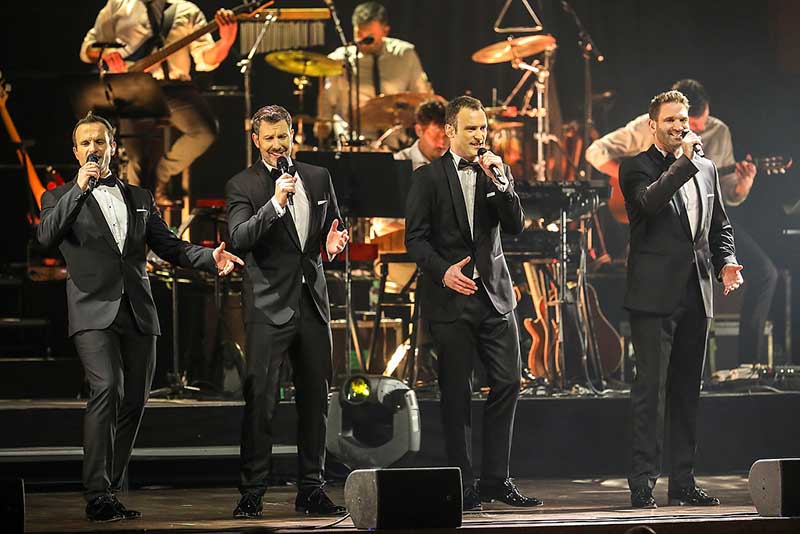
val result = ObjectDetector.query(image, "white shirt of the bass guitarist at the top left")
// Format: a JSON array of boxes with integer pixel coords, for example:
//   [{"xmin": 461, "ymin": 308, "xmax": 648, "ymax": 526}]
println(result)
[{"xmin": 80, "ymin": 0, "xmax": 219, "ymax": 80}]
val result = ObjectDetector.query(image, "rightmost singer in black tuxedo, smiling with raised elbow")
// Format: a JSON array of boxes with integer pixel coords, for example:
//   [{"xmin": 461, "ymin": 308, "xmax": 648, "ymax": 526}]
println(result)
[{"xmin": 620, "ymin": 91, "xmax": 743, "ymax": 508}]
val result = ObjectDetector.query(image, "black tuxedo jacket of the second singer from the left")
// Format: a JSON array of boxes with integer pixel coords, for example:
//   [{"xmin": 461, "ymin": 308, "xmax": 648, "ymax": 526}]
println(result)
[{"xmin": 225, "ymin": 160, "xmax": 341, "ymax": 325}]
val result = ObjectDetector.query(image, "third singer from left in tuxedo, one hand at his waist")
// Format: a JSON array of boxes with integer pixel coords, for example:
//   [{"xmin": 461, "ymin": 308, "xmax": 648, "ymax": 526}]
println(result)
[{"xmin": 406, "ymin": 96, "xmax": 542, "ymax": 510}]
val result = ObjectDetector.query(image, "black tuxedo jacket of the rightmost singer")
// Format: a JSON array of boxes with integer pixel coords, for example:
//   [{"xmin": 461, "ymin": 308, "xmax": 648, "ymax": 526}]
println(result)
[{"xmin": 620, "ymin": 145, "xmax": 737, "ymax": 317}]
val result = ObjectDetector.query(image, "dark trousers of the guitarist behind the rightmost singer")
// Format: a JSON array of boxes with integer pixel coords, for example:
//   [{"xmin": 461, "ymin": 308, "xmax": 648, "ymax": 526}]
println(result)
[{"xmin": 733, "ymin": 222, "xmax": 778, "ymax": 363}]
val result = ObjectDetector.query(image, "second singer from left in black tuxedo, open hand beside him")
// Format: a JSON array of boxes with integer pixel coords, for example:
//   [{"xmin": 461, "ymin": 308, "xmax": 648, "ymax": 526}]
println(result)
[{"xmin": 225, "ymin": 106, "xmax": 348, "ymax": 518}]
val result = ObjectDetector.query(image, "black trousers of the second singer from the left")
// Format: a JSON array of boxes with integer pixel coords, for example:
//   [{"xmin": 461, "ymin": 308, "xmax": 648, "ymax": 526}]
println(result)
[{"xmin": 239, "ymin": 284, "xmax": 333, "ymax": 495}]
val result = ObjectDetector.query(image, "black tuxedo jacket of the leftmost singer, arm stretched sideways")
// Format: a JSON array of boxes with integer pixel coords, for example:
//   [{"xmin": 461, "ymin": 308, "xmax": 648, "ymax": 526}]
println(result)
[{"xmin": 36, "ymin": 181, "xmax": 217, "ymax": 336}]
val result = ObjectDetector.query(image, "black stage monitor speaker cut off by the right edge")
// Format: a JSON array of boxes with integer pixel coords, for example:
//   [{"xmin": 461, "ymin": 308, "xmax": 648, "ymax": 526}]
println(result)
[{"xmin": 749, "ymin": 458, "xmax": 800, "ymax": 517}]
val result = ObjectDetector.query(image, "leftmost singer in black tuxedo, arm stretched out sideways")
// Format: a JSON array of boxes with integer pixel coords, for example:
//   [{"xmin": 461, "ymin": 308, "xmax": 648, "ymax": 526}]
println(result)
[{"xmin": 36, "ymin": 114, "xmax": 241, "ymax": 521}]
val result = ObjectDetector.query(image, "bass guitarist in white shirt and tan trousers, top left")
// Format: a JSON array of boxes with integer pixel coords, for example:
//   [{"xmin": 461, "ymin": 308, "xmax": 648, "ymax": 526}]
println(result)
[{"xmin": 80, "ymin": 0, "xmax": 238, "ymax": 205}]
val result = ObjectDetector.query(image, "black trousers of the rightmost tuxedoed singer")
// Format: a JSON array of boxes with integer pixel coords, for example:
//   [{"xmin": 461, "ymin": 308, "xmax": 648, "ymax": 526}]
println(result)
[{"xmin": 628, "ymin": 270, "xmax": 709, "ymax": 490}]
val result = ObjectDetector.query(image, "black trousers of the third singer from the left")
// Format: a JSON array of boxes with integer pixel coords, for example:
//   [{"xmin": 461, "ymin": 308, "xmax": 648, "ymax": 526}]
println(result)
[{"xmin": 431, "ymin": 281, "xmax": 521, "ymax": 487}]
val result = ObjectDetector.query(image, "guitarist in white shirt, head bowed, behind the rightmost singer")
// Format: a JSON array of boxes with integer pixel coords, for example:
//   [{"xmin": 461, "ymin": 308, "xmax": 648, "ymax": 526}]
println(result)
[{"xmin": 586, "ymin": 79, "xmax": 778, "ymax": 363}]
